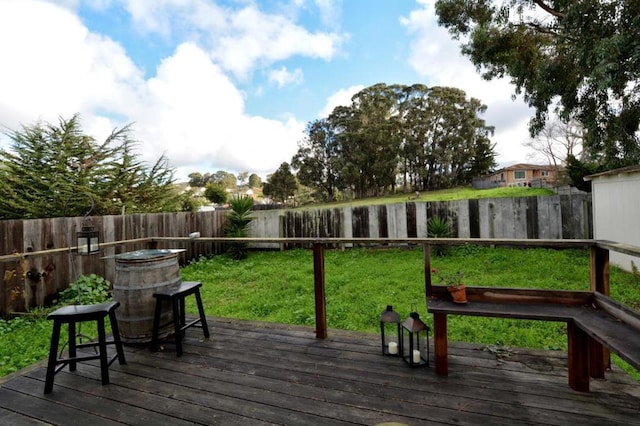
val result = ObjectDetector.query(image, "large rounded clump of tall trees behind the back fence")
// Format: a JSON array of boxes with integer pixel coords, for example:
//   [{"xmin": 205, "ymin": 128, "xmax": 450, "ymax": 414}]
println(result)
[{"xmin": 292, "ymin": 83, "xmax": 495, "ymax": 198}]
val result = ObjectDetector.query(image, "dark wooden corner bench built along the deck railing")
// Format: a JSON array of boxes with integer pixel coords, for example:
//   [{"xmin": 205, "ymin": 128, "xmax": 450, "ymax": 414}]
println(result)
[{"xmin": 427, "ymin": 286, "xmax": 640, "ymax": 392}]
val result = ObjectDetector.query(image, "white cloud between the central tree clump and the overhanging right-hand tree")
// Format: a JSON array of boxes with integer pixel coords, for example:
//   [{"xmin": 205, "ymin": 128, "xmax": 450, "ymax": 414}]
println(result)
[{"xmin": 401, "ymin": 0, "xmax": 533, "ymax": 163}]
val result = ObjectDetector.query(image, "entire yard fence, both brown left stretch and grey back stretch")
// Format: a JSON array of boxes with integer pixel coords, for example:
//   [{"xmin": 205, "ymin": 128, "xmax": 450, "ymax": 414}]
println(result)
[{"xmin": 0, "ymin": 195, "xmax": 593, "ymax": 315}]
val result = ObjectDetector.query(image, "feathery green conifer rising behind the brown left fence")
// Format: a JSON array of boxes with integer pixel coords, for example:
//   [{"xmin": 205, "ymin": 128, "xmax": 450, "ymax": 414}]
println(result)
[{"xmin": 0, "ymin": 115, "xmax": 183, "ymax": 219}]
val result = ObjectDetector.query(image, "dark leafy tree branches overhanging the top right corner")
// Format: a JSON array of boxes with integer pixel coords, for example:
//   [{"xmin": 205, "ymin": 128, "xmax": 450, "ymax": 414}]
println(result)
[{"xmin": 436, "ymin": 0, "xmax": 640, "ymax": 168}]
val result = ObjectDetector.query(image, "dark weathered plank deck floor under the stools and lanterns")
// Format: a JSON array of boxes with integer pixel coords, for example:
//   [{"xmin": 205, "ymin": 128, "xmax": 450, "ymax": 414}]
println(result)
[{"xmin": 0, "ymin": 318, "xmax": 640, "ymax": 426}]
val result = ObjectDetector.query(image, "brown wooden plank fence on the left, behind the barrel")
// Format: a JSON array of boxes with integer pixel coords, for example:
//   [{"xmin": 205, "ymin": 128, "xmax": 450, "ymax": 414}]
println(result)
[{"xmin": 0, "ymin": 212, "xmax": 225, "ymax": 315}]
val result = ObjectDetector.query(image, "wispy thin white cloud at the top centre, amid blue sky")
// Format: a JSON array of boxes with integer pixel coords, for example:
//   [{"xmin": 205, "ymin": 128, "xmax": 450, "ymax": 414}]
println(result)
[{"xmin": 116, "ymin": 0, "xmax": 343, "ymax": 80}]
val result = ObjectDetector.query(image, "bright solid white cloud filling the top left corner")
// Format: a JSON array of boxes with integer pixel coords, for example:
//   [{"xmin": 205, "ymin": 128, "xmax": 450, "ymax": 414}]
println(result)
[{"xmin": 0, "ymin": 0, "xmax": 142, "ymax": 133}]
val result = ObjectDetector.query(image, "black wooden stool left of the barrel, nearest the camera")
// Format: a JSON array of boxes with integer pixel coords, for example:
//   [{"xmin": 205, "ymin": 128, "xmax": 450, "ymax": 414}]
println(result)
[{"xmin": 44, "ymin": 302, "xmax": 126, "ymax": 393}]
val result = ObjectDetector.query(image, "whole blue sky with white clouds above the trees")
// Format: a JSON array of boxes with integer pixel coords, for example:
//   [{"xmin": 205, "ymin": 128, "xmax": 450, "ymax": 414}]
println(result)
[{"xmin": 0, "ymin": 0, "xmax": 535, "ymax": 180}]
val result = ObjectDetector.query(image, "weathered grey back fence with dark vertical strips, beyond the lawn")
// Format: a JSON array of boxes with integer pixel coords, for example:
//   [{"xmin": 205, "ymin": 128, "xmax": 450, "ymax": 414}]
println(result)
[{"xmin": 251, "ymin": 194, "xmax": 593, "ymax": 246}]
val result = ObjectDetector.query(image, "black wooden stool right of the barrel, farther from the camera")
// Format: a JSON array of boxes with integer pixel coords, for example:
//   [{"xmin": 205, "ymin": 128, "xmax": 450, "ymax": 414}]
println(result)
[{"xmin": 151, "ymin": 281, "xmax": 209, "ymax": 356}]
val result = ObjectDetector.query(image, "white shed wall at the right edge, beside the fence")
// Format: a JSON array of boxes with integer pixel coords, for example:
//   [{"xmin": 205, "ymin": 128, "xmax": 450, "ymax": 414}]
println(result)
[{"xmin": 585, "ymin": 165, "xmax": 640, "ymax": 271}]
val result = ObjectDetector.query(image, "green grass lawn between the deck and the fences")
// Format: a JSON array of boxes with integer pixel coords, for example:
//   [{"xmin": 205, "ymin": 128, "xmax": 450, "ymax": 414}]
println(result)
[{"xmin": 0, "ymin": 246, "xmax": 640, "ymax": 380}]
